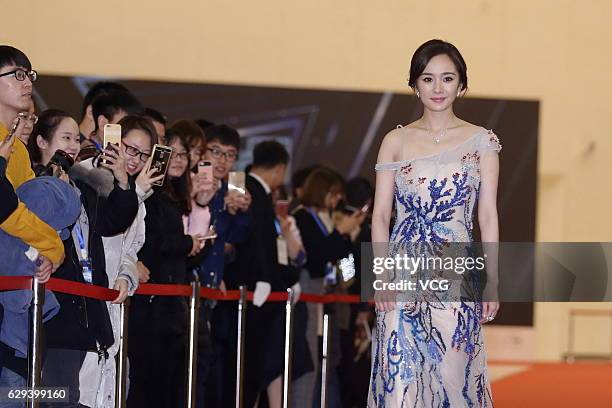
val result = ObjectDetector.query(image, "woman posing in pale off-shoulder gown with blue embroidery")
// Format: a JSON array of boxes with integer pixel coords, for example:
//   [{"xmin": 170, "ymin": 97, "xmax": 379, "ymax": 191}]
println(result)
[{"xmin": 368, "ymin": 40, "xmax": 501, "ymax": 408}]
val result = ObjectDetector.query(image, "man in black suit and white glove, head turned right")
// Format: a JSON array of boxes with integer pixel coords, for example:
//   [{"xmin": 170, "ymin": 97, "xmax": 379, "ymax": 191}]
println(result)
[{"xmin": 236, "ymin": 141, "xmax": 298, "ymax": 407}]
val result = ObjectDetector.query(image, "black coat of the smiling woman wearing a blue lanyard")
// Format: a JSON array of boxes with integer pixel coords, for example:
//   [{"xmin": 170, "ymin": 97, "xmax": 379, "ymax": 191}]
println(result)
[{"xmin": 45, "ymin": 180, "xmax": 138, "ymax": 350}]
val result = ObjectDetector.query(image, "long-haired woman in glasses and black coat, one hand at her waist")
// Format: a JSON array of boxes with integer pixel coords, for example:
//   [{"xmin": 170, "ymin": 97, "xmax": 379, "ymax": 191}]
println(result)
[{"xmin": 128, "ymin": 130, "xmax": 205, "ymax": 407}]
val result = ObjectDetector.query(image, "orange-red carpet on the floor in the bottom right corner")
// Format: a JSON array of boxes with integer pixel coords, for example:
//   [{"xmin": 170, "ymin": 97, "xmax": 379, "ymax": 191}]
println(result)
[{"xmin": 493, "ymin": 363, "xmax": 612, "ymax": 408}]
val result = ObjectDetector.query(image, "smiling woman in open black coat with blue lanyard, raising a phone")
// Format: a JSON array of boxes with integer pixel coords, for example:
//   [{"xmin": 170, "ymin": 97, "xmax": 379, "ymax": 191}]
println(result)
[{"xmin": 28, "ymin": 109, "xmax": 138, "ymax": 406}]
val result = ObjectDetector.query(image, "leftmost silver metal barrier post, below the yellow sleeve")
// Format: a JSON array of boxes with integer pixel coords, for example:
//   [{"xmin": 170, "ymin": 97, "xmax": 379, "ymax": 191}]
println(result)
[{"xmin": 27, "ymin": 277, "xmax": 45, "ymax": 408}]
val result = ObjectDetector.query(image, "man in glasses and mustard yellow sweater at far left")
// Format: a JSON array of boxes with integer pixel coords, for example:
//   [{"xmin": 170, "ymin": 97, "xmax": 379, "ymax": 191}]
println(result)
[{"xmin": 0, "ymin": 45, "xmax": 64, "ymax": 387}]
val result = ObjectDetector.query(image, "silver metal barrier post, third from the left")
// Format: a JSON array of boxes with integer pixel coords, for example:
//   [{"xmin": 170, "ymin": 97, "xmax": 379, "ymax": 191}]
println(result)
[{"xmin": 185, "ymin": 273, "xmax": 200, "ymax": 408}]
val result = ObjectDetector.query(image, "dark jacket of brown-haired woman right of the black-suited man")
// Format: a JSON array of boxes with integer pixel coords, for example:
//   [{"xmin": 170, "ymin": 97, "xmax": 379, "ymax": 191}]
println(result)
[{"xmin": 293, "ymin": 207, "xmax": 353, "ymax": 278}]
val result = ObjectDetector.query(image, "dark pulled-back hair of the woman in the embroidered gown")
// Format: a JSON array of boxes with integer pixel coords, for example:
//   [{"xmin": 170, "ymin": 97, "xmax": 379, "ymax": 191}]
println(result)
[{"xmin": 408, "ymin": 40, "xmax": 467, "ymax": 91}]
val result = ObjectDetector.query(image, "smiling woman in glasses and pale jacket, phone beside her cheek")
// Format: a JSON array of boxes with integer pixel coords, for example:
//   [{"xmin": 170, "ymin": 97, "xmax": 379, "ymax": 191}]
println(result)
[{"xmin": 71, "ymin": 115, "xmax": 163, "ymax": 408}]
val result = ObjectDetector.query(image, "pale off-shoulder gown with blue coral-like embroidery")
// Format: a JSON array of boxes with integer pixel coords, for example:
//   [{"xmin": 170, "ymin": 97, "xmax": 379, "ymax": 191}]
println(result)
[{"xmin": 368, "ymin": 129, "xmax": 501, "ymax": 408}]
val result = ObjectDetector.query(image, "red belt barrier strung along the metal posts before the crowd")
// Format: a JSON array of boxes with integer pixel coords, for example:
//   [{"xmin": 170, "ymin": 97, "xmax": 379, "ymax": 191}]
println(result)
[{"xmin": 0, "ymin": 276, "xmax": 361, "ymax": 303}]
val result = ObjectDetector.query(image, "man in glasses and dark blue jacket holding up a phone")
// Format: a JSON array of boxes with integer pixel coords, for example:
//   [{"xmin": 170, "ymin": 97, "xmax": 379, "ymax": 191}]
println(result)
[{"xmin": 194, "ymin": 125, "xmax": 251, "ymax": 406}]
